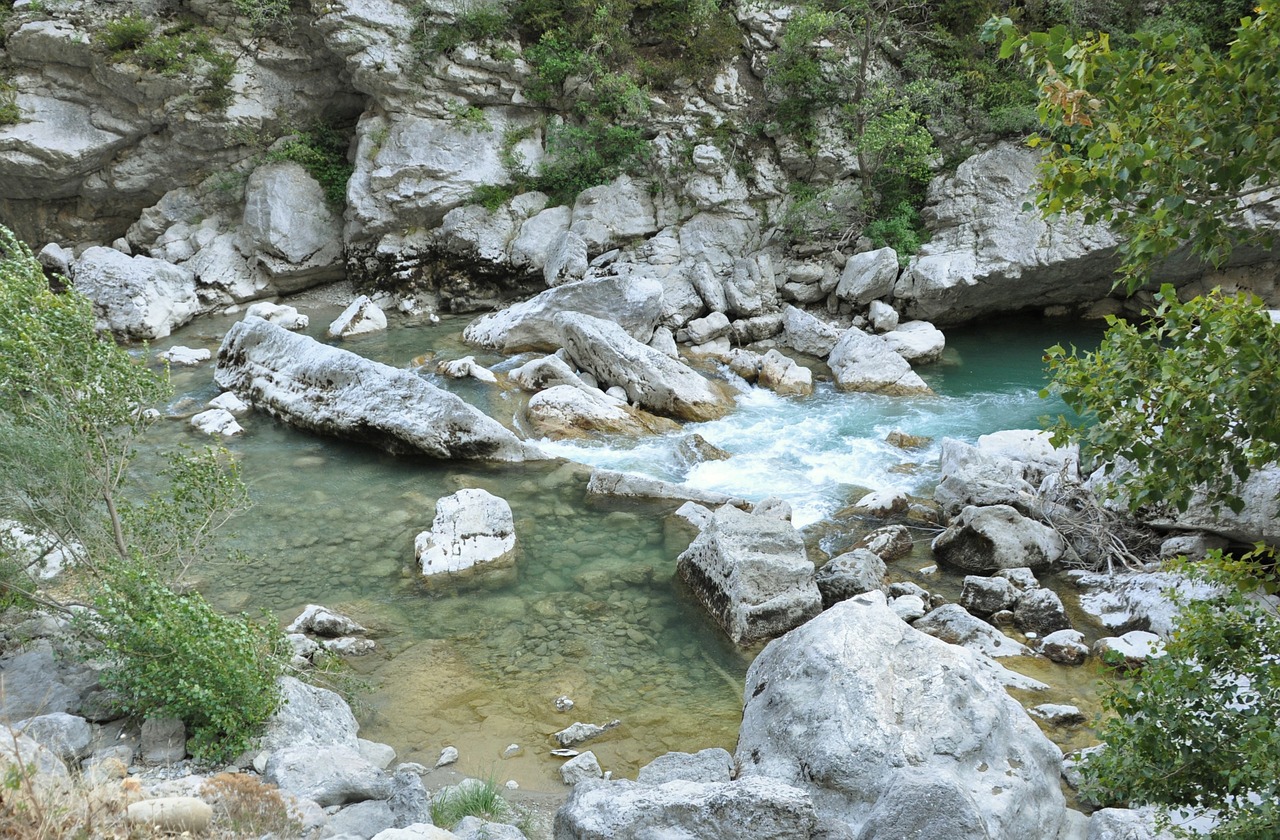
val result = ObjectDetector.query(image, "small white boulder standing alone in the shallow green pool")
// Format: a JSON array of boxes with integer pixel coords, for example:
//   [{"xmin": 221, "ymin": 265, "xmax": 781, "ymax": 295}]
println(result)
[{"xmin": 413, "ymin": 488, "xmax": 516, "ymax": 575}]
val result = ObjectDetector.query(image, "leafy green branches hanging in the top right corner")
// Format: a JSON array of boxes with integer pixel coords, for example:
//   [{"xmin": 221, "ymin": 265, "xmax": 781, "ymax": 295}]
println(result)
[{"xmin": 987, "ymin": 0, "xmax": 1280, "ymax": 291}]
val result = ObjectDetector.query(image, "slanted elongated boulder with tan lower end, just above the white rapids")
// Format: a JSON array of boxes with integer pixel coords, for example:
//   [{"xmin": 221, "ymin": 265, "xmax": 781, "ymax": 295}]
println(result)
[{"xmin": 554, "ymin": 312, "xmax": 732, "ymax": 420}]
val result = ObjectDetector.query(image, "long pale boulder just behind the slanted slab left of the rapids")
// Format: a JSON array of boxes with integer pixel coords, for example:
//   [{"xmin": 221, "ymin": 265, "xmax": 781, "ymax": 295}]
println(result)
[{"xmin": 462, "ymin": 277, "xmax": 662, "ymax": 353}]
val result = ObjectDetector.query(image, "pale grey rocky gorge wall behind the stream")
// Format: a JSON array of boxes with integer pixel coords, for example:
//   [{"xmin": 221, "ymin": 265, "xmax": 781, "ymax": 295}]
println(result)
[{"xmin": 0, "ymin": 0, "xmax": 1276, "ymax": 332}]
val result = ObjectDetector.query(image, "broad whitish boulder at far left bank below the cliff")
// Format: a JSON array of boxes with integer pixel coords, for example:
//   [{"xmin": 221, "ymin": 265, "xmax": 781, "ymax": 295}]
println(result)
[{"xmin": 72, "ymin": 247, "xmax": 200, "ymax": 339}]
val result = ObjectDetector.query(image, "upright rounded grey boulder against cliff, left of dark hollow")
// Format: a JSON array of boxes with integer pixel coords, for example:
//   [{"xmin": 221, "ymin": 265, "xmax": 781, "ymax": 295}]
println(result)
[{"xmin": 241, "ymin": 160, "xmax": 343, "ymax": 292}]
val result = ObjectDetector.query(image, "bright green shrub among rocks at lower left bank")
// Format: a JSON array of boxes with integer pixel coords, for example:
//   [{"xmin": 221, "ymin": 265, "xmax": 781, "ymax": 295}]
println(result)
[{"xmin": 91, "ymin": 562, "xmax": 288, "ymax": 762}]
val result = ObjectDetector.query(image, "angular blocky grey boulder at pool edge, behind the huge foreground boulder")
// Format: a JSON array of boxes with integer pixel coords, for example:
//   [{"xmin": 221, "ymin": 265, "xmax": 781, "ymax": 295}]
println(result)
[{"xmin": 676, "ymin": 506, "xmax": 822, "ymax": 644}]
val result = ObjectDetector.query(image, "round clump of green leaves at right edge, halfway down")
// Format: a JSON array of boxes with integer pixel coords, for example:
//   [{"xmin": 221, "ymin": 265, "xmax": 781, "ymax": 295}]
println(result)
[{"xmin": 1046, "ymin": 286, "xmax": 1280, "ymax": 512}]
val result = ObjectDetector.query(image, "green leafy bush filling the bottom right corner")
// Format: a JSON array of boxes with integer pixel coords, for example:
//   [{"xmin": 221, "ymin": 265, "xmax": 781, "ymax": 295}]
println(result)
[{"xmin": 1082, "ymin": 553, "xmax": 1280, "ymax": 840}]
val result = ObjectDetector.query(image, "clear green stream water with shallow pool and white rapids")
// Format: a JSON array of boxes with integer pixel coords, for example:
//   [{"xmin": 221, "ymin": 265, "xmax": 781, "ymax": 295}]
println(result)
[{"xmin": 149, "ymin": 309, "xmax": 1093, "ymax": 790}]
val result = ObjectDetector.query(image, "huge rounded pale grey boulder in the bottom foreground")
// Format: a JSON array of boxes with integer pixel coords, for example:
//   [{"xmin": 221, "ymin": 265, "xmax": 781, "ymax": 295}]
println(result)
[{"xmin": 735, "ymin": 593, "xmax": 1066, "ymax": 840}]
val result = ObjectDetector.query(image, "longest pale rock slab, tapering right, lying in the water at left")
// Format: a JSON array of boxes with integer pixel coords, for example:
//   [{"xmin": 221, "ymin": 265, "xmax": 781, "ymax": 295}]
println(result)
[{"xmin": 214, "ymin": 318, "xmax": 541, "ymax": 461}]
